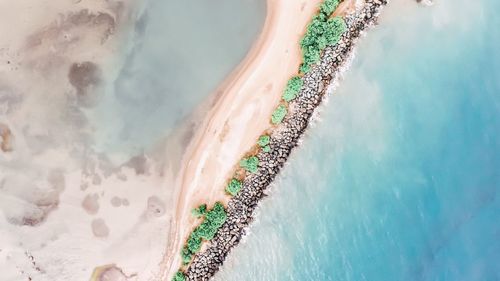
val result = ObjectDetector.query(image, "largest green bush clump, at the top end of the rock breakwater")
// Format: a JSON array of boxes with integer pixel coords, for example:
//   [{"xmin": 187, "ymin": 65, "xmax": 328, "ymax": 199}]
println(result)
[{"xmin": 300, "ymin": 0, "xmax": 346, "ymax": 73}]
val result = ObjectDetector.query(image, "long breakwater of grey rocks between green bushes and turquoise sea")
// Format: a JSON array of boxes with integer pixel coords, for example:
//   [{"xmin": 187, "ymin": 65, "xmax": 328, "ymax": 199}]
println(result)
[{"xmin": 185, "ymin": 0, "xmax": 387, "ymax": 280}]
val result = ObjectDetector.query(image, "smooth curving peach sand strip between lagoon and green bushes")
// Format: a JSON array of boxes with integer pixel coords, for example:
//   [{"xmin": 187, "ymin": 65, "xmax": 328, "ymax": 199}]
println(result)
[{"xmin": 159, "ymin": 0, "xmax": 321, "ymax": 280}]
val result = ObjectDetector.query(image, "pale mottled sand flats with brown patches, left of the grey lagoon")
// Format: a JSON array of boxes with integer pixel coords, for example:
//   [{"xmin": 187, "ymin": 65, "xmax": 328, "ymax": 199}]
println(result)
[{"xmin": 0, "ymin": 0, "xmax": 174, "ymax": 281}]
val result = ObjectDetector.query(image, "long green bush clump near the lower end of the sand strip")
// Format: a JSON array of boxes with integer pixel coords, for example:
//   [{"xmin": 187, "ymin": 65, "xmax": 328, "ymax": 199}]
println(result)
[{"xmin": 181, "ymin": 202, "xmax": 227, "ymax": 264}]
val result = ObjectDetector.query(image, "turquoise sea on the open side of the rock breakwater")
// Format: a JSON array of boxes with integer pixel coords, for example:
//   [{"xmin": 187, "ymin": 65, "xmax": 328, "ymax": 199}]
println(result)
[{"xmin": 216, "ymin": 0, "xmax": 500, "ymax": 281}]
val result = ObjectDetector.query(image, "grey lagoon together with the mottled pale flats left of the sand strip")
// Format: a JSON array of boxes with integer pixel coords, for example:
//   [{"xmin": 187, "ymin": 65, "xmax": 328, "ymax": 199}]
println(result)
[{"xmin": 0, "ymin": 0, "xmax": 266, "ymax": 281}]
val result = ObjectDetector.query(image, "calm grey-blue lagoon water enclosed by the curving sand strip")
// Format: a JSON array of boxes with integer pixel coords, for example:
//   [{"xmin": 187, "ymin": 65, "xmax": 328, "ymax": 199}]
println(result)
[{"xmin": 89, "ymin": 0, "xmax": 266, "ymax": 159}]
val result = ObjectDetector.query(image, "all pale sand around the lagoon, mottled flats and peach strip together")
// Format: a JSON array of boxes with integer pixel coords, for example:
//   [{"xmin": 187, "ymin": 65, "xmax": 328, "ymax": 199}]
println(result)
[{"xmin": 0, "ymin": 0, "xmax": 352, "ymax": 281}]
